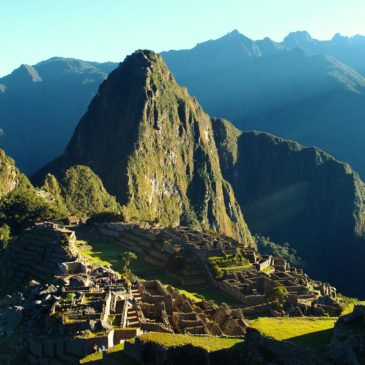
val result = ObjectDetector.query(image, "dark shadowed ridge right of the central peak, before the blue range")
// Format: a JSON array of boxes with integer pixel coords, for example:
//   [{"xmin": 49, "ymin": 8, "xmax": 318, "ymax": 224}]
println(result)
[{"xmin": 213, "ymin": 120, "xmax": 365, "ymax": 295}]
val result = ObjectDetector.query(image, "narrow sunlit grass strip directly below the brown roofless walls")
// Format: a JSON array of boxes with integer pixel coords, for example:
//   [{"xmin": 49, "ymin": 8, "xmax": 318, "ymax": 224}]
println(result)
[{"xmin": 139, "ymin": 332, "xmax": 243, "ymax": 352}]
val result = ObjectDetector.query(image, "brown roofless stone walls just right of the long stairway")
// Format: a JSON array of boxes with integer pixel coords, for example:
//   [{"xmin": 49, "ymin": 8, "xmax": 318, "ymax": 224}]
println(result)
[{"xmin": 136, "ymin": 280, "xmax": 249, "ymax": 336}]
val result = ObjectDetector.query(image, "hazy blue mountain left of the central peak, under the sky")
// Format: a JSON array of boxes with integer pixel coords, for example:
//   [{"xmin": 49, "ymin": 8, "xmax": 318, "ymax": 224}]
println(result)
[{"xmin": 0, "ymin": 57, "xmax": 116, "ymax": 174}]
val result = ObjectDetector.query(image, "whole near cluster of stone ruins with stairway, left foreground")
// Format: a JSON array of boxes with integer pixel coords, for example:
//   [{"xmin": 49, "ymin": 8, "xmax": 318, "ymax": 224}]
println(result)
[{"xmin": 21, "ymin": 267, "xmax": 249, "ymax": 364}]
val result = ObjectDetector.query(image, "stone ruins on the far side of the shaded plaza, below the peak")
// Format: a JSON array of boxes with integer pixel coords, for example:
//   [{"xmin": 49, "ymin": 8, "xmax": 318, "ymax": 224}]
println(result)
[{"xmin": 96, "ymin": 223, "xmax": 341, "ymax": 316}]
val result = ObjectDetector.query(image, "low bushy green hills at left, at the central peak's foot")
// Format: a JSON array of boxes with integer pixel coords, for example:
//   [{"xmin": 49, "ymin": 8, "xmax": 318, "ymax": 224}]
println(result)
[{"xmin": 0, "ymin": 150, "xmax": 120, "ymax": 235}]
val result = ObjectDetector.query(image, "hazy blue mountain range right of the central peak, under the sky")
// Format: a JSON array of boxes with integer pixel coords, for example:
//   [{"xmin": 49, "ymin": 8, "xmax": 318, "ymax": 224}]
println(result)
[{"xmin": 162, "ymin": 32, "xmax": 365, "ymax": 177}]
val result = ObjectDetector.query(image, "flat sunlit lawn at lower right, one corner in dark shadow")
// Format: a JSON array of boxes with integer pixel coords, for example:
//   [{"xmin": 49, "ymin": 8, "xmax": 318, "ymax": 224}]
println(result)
[{"xmin": 251, "ymin": 317, "xmax": 337, "ymax": 350}]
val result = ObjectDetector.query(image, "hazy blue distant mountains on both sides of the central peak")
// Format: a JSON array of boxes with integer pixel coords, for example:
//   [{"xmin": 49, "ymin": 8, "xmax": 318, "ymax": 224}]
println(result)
[{"xmin": 0, "ymin": 31, "xmax": 365, "ymax": 177}]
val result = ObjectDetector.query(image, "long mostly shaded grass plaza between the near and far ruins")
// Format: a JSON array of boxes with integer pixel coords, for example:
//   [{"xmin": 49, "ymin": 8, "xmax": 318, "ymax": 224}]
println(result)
[{"xmin": 77, "ymin": 241, "xmax": 241, "ymax": 307}]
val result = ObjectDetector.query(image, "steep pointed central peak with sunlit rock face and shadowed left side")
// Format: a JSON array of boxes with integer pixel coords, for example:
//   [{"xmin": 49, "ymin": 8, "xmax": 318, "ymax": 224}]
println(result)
[{"xmin": 38, "ymin": 51, "xmax": 253, "ymax": 244}]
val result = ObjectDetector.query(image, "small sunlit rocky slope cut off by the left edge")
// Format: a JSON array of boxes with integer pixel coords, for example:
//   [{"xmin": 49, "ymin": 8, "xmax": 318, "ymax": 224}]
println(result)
[{"xmin": 0, "ymin": 149, "xmax": 22, "ymax": 198}]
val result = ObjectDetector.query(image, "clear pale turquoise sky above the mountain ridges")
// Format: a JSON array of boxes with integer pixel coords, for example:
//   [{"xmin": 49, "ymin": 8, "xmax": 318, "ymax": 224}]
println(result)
[{"xmin": 0, "ymin": 0, "xmax": 365, "ymax": 76}]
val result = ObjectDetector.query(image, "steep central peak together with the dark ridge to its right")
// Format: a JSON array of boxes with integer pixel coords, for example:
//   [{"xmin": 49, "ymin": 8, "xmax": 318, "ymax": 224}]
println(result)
[{"xmin": 33, "ymin": 51, "xmax": 365, "ymax": 296}]
